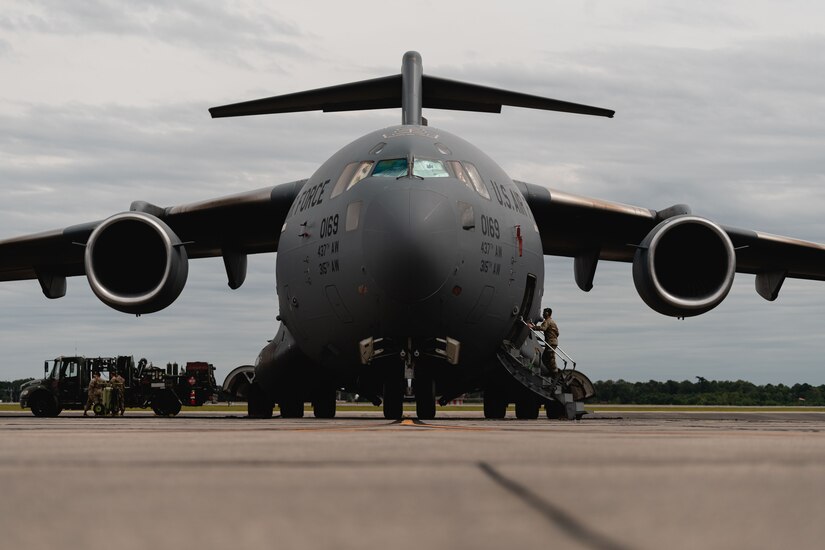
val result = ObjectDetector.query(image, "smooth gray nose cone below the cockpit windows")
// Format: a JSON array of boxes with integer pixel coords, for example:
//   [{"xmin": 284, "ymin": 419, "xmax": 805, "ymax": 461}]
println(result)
[{"xmin": 364, "ymin": 188, "xmax": 458, "ymax": 303}]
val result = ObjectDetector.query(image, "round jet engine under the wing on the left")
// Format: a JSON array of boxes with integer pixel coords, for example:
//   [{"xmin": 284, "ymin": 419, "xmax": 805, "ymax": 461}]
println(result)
[{"xmin": 84, "ymin": 212, "xmax": 189, "ymax": 314}]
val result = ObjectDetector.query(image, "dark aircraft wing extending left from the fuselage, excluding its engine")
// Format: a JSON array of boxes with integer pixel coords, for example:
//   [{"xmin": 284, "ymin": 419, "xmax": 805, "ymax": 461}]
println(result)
[{"xmin": 0, "ymin": 180, "xmax": 306, "ymax": 297}]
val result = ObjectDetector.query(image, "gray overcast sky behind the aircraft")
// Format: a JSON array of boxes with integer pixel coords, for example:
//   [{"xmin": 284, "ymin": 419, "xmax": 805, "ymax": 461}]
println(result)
[{"xmin": 0, "ymin": 0, "xmax": 825, "ymax": 384}]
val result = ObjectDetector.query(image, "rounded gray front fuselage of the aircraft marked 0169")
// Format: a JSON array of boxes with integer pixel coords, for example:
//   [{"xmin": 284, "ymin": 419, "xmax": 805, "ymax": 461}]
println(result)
[{"xmin": 277, "ymin": 125, "xmax": 544, "ymax": 379}]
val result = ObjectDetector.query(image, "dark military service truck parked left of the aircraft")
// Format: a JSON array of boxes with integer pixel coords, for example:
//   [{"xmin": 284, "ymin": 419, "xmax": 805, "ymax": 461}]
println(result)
[{"xmin": 20, "ymin": 356, "xmax": 218, "ymax": 416}]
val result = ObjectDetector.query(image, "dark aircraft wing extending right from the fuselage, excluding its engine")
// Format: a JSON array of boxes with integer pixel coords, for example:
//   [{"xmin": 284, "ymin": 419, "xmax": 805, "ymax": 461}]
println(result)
[{"xmin": 515, "ymin": 182, "xmax": 825, "ymax": 309}]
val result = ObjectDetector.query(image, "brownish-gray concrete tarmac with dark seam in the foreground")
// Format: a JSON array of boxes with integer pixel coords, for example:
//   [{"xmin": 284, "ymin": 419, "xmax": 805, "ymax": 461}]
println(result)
[{"xmin": 0, "ymin": 412, "xmax": 825, "ymax": 550}]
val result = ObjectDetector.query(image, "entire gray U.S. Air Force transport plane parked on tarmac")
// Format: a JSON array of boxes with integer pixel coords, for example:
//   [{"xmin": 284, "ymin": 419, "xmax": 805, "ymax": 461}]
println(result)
[{"xmin": 0, "ymin": 52, "xmax": 825, "ymax": 418}]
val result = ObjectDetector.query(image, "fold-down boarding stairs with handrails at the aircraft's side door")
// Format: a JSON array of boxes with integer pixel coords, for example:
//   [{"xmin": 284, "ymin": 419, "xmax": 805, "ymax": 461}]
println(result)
[{"xmin": 496, "ymin": 319, "xmax": 595, "ymax": 420}]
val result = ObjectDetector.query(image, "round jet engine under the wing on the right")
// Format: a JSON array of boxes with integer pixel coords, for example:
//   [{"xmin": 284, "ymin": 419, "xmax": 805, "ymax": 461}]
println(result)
[{"xmin": 633, "ymin": 215, "xmax": 736, "ymax": 317}]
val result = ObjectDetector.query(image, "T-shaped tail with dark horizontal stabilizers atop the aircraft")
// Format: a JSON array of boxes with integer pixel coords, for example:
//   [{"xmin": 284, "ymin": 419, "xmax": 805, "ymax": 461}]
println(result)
[{"xmin": 209, "ymin": 52, "xmax": 615, "ymax": 125}]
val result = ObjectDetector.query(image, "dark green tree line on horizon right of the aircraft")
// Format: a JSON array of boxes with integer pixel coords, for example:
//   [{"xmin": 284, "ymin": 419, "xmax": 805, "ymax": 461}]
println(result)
[{"xmin": 588, "ymin": 382, "xmax": 825, "ymax": 406}]
